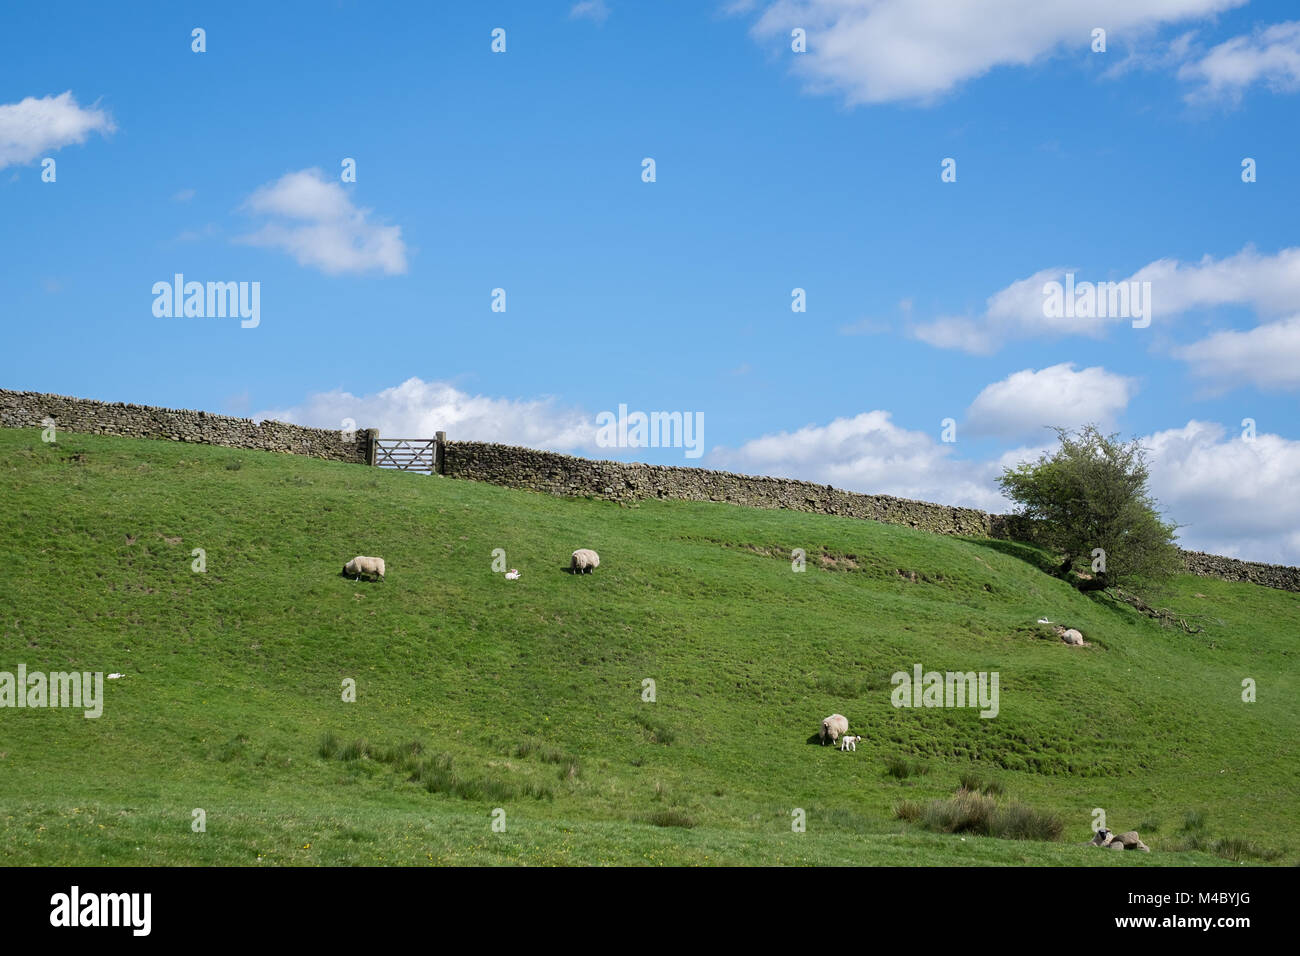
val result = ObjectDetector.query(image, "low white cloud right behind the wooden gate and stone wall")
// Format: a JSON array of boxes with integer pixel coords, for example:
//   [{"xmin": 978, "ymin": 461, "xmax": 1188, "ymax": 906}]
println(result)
[{"xmin": 254, "ymin": 378, "xmax": 595, "ymax": 451}]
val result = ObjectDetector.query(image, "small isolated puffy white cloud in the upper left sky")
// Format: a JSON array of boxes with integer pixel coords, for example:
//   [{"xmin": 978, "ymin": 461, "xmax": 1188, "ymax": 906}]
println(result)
[{"xmin": 237, "ymin": 169, "xmax": 407, "ymax": 276}]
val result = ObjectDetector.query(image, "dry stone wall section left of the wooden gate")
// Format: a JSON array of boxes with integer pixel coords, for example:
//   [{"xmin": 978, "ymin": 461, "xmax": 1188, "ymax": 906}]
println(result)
[{"xmin": 0, "ymin": 389, "xmax": 378, "ymax": 464}]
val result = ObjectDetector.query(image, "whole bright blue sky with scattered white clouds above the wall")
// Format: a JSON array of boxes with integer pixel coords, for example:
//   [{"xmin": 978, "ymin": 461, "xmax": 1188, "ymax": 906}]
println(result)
[{"xmin": 0, "ymin": 0, "xmax": 1300, "ymax": 563}]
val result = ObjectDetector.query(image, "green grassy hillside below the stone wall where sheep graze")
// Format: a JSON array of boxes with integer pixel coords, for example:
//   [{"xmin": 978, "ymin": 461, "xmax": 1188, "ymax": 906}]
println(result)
[{"xmin": 0, "ymin": 429, "xmax": 1300, "ymax": 866}]
